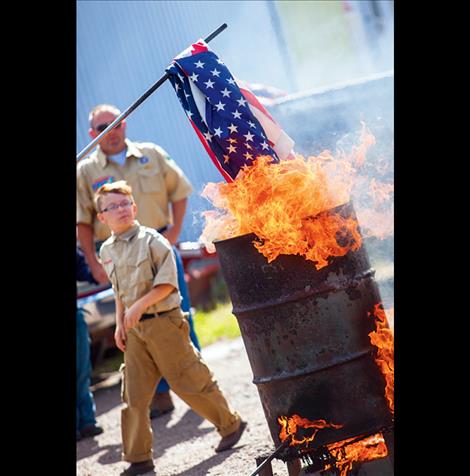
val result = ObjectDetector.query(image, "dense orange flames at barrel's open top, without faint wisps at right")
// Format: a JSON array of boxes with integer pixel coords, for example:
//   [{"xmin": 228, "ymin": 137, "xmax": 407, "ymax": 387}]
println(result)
[{"xmin": 201, "ymin": 154, "xmax": 362, "ymax": 269}]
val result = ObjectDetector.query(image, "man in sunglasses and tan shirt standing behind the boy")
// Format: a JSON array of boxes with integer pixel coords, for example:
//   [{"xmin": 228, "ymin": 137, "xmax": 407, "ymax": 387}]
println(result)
[{"xmin": 77, "ymin": 104, "xmax": 200, "ymax": 417}]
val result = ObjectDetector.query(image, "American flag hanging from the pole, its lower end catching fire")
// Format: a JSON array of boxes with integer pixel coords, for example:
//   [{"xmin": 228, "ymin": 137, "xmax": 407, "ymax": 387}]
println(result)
[{"xmin": 166, "ymin": 40, "xmax": 294, "ymax": 182}]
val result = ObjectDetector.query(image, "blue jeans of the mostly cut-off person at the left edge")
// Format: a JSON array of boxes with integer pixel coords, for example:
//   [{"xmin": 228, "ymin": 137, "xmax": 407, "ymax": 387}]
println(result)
[{"xmin": 76, "ymin": 308, "xmax": 96, "ymax": 435}]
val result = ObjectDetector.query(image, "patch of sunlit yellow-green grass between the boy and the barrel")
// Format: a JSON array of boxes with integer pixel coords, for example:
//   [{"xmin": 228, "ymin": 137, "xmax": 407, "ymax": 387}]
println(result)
[{"xmin": 193, "ymin": 302, "xmax": 240, "ymax": 347}]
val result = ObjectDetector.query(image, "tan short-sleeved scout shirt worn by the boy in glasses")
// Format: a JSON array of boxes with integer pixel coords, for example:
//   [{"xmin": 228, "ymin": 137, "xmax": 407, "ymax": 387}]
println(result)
[{"xmin": 100, "ymin": 221, "xmax": 181, "ymax": 313}]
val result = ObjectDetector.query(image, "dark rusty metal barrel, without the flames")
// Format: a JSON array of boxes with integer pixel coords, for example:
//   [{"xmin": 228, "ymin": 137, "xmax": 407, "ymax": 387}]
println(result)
[{"xmin": 214, "ymin": 203, "xmax": 392, "ymax": 448}]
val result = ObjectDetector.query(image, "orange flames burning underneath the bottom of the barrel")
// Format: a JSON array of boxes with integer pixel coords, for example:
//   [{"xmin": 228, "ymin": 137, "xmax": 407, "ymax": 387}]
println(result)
[{"xmin": 325, "ymin": 433, "xmax": 388, "ymax": 476}]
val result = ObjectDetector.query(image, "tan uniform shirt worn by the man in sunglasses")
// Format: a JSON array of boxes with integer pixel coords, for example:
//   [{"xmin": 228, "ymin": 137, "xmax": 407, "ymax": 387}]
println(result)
[{"xmin": 77, "ymin": 139, "xmax": 192, "ymax": 240}]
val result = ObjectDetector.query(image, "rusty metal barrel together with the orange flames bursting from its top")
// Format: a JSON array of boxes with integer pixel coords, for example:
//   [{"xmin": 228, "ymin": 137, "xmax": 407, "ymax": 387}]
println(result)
[{"xmin": 205, "ymin": 126, "xmax": 393, "ymax": 474}]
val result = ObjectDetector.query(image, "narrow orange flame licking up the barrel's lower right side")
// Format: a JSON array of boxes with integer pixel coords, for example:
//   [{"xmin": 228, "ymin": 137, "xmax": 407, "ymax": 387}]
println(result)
[{"xmin": 368, "ymin": 303, "xmax": 395, "ymax": 414}]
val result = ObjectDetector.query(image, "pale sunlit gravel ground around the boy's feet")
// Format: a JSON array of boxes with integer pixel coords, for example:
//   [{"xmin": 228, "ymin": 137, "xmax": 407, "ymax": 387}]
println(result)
[{"xmin": 77, "ymin": 338, "xmax": 288, "ymax": 476}]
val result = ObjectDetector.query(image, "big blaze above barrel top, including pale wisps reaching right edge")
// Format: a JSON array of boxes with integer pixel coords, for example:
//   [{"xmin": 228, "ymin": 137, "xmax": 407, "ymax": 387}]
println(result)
[{"xmin": 200, "ymin": 123, "xmax": 393, "ymax": 269}]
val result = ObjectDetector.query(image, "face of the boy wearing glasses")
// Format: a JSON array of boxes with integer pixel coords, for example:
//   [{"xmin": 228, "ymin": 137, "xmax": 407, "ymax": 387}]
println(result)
[{"xmin": 98, "ymin": 193, "xmax": 137, "ymax": 233}]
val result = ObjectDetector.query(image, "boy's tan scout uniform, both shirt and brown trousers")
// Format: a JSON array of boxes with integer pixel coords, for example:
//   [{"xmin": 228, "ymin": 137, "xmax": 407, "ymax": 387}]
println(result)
[{"xmin": 100, "ymin": 224, "xmax": 241, "ymax": 463}]
